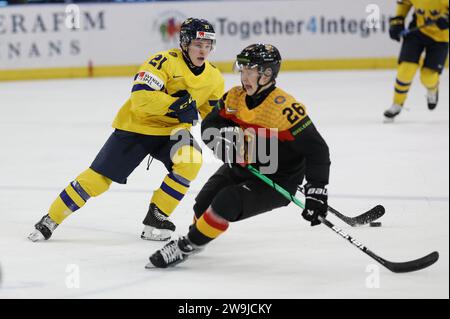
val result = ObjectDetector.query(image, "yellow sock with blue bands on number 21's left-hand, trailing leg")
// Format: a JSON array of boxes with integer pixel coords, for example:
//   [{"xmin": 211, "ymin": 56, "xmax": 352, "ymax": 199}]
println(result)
[{"xmin": 49, "ymin": 169, "xmax": 112, "ymax": 225}]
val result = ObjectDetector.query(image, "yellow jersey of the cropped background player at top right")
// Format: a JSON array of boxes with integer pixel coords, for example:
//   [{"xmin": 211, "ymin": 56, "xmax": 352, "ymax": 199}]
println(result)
[{"xmin": 397, "ymin": 0, "xmax": 449, "ymax": 42}]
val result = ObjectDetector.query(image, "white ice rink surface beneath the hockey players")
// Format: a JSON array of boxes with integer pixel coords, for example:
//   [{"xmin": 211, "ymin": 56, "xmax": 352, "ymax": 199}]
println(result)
[{"xmin": 0, "ymin": 70, "xmax": 449, "ymax": 299}]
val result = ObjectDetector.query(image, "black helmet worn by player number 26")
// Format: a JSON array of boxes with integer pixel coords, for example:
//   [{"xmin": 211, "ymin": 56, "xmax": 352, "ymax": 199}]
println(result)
[{"xmin": 236, "ymin": 43, "xmax": 281, "ymax": 80}]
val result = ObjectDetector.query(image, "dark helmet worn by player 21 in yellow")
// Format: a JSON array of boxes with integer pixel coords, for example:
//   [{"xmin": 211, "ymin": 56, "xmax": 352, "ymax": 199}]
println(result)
[{"xmin": 180, "ymin": 18, "xmax": 216, "ymax": 51}]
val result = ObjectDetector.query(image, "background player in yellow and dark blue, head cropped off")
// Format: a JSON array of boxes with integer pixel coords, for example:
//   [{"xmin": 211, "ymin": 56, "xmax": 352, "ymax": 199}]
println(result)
[{"xmin": 384, "ymin": 0, "xmax": 449, "ymax": 122}]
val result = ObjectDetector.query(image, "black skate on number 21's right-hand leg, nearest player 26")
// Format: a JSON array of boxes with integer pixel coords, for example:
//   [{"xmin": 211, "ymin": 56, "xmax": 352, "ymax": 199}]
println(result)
[{"xmin": 141, "ymin": 203, "xmax": 175, "ymax": 241}]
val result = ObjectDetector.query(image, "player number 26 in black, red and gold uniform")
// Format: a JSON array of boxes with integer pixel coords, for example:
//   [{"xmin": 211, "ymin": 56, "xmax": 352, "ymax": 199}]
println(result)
[{"xmin": 147, "ymin": 44, "xmax": 330, "ymax": 268}]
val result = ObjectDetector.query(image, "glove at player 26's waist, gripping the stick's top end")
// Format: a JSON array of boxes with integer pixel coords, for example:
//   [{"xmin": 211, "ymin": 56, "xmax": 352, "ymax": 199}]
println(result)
[{"xmin": 214, "ymin": 126, "xmax": 245, "ymax": 167}]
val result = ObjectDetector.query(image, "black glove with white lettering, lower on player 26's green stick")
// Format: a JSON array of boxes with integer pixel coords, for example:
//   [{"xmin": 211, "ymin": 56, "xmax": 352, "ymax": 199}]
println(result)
[{"xmin": 302, "ymin": 184, "xmax": 328, "ymax": 226}]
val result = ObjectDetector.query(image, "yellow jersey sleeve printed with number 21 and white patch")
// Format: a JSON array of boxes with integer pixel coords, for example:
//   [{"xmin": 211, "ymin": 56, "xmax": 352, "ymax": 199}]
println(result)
[{"xmin": 131, "ymin": 52, "xmax": 177, "ymax": 115}]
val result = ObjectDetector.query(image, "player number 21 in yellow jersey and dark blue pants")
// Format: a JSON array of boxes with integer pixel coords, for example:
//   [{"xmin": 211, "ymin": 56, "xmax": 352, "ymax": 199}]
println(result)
[{"xmin": 29, "ymin": 18, "xmax": 224, "ymax": 241}]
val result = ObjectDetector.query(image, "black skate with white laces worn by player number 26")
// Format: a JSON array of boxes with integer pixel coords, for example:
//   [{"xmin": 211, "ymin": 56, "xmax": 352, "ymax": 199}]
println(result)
[{"xmin": 145, "ymin": 237, "xmax": 202, "ymax": 269}]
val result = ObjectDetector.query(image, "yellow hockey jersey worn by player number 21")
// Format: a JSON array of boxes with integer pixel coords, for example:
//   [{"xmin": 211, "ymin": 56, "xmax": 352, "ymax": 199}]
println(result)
[{"xmin": 113, "ymin": 49, "xmax": 225, "ymax": 135}]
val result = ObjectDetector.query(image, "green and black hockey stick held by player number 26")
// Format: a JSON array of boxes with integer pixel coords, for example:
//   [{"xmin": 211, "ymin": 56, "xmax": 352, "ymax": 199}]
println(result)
[{"xmin": 247, "ymin": 165, "xmax": 439, "ymax": 273}]
